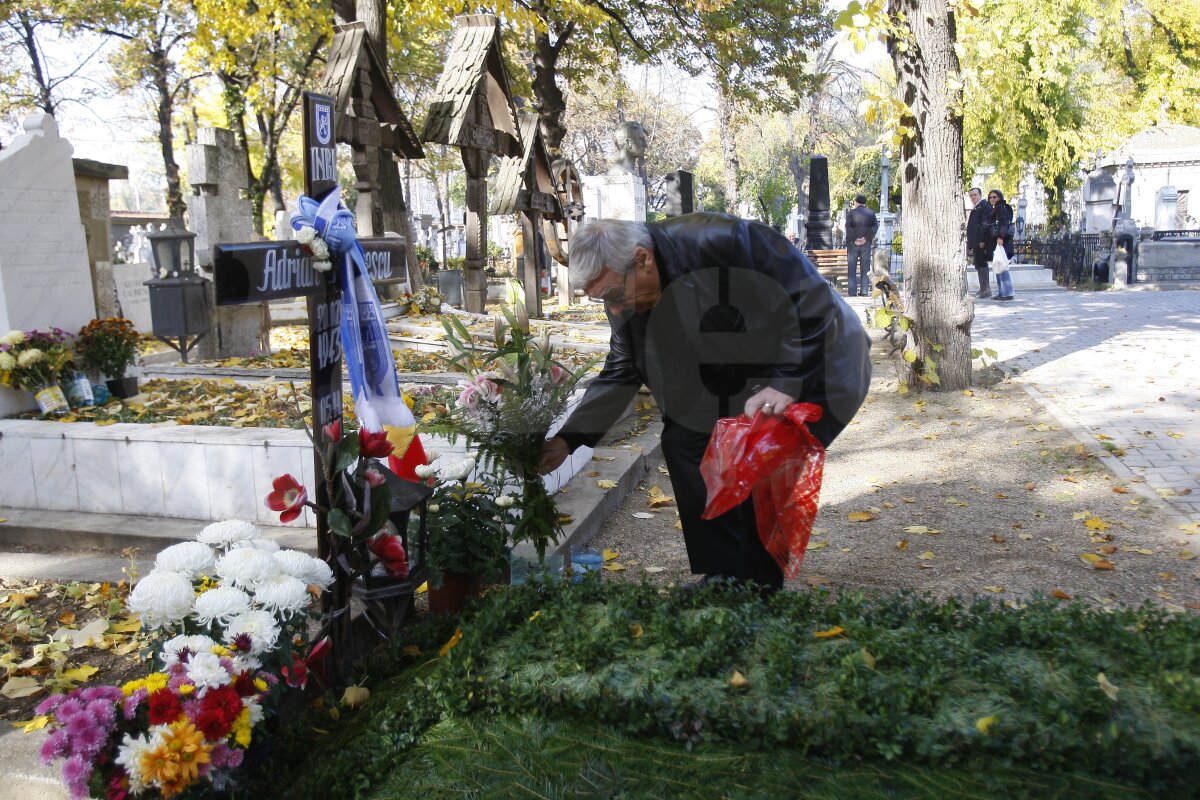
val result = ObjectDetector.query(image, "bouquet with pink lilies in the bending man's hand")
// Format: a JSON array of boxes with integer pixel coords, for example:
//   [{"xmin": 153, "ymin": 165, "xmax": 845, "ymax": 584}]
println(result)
[{"xmin": 442, "ymin": 281, "xmax": 594, "ymax": 563}]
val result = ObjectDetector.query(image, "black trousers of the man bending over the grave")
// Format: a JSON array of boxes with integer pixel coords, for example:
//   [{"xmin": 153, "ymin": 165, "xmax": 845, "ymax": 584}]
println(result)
[{"xmin": 662, "ymin": 419, "xmax": 784, "ymax": 588}]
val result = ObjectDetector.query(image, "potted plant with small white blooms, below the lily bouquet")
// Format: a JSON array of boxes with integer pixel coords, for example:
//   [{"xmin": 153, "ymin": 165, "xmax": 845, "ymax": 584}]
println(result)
[{"xmin": 418, "ymin": 458, "xmax": 516, "ymax": 612}]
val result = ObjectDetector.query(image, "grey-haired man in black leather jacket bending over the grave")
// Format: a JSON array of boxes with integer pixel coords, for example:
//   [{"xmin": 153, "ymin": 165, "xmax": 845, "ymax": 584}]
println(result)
[{"xmin": 542, "ymin": 213, "xmax": 871, "ymax": 588}]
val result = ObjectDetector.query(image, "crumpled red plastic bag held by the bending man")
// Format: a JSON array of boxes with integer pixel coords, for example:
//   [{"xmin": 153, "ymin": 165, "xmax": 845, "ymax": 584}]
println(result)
[{"xmin": 700, "ymin": 403, "xmax": 824, "ymax": 578}]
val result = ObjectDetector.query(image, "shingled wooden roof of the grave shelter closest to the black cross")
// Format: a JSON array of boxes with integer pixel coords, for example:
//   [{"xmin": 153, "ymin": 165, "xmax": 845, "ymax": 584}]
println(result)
[{"xmin": 325, "ymin": 22, "xmax": 425, "ymax": 158}]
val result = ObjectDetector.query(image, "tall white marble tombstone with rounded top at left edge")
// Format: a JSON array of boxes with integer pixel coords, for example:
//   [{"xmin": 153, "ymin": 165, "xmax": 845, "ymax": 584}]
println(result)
[{"xmin": 0, "ymin": 114, "xmax": 96, "ymax": 416}]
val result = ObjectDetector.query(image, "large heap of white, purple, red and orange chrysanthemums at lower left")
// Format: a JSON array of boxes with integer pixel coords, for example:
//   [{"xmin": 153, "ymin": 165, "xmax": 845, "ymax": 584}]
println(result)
[{"xmin": 37, "ymin": 521, "xmax": 332, "ymax": 799}]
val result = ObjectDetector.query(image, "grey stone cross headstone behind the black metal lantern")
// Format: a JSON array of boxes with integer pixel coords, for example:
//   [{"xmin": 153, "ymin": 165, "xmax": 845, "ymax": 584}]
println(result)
[{"xmin": 187, "ymin": 128, "xmax": 271, "ymax": 359}]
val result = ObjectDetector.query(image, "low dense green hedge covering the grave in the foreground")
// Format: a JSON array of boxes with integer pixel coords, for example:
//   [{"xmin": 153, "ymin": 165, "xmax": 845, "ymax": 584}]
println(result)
[{"xmin": 253, "ymin": 577, "xmax": 1200, "ymax": 796}]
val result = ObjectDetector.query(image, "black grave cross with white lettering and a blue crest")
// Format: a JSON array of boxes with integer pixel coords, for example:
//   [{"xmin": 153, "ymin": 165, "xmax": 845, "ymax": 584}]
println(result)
[{"xmin": 212, "ymin": 92, "xmax": 406, "ymax": 657}]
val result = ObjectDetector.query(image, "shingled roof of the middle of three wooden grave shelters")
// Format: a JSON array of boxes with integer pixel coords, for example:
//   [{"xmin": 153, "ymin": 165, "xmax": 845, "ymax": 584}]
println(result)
[{"xmin": 421, "ymin": 14, "xmax": 521, "ymax": 156}]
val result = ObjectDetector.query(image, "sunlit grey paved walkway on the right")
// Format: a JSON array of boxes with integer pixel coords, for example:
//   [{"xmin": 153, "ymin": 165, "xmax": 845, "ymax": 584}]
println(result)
[{"xmin": 972, "ymin": 290, "xmax": 1200, "ymax": 523}]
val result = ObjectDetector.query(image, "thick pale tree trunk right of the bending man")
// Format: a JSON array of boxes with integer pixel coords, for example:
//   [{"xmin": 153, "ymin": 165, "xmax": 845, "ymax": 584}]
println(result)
[{"xmin": 889, "ymin": 0, "xmax": 974, "ymax": 391}]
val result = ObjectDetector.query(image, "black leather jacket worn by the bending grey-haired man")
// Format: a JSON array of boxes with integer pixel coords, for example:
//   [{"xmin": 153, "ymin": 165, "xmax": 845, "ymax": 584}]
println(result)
[{"xmin": 559, "ymin": 212, "xmax": 871, "ymax": 451}]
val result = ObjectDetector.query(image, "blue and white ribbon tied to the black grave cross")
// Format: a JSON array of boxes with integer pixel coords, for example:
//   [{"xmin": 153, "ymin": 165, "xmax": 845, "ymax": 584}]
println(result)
[{"xmin": 292, "ymin": 186, "xmax": 413, "ymax": 432}]
